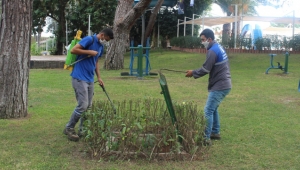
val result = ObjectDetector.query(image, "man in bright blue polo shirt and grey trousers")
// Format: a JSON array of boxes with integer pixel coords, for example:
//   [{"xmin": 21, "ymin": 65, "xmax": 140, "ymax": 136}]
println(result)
[{"xmin": 63, "ymin": 28, "xmax": 114, "ymax": 141}]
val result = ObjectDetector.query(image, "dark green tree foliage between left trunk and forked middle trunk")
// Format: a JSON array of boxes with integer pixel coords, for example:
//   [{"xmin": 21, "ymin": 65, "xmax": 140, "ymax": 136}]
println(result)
[{"xmin": 33, "ymin": 0, "xmax": 117, "ymax": 54}]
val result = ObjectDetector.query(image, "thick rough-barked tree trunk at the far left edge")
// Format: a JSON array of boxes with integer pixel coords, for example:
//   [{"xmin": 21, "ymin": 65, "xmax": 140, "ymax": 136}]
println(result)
[{"xmin": 0, "ymin": 0, "xmax": 32, "ymax": 119}]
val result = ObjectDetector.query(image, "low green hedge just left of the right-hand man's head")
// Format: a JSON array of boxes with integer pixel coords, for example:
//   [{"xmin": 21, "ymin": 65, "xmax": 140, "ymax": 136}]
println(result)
[{"xmin": 170, "ymin": 36, "xmax": 204, "ymax": 49}]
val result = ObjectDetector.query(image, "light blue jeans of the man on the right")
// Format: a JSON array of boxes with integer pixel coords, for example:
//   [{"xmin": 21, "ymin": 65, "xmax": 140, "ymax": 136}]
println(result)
[{"xmin": 204, "ymin": 89, "xmax": 231, "ymax": 139}]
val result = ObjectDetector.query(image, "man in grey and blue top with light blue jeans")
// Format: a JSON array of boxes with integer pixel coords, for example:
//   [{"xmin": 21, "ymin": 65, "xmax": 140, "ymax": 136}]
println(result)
[{"xmin": 186, "ymin": 29, "xmax": 231, "ymax": 145}]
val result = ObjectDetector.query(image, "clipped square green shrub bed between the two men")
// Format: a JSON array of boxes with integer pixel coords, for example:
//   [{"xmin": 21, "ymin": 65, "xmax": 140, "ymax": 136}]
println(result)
[{"xmin": 84, "ymin": 98, "xmax": 205, "ymax": 160}]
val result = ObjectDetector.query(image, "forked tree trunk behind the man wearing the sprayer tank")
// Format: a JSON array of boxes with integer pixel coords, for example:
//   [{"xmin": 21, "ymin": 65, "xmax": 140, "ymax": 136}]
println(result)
[{"xmin": 104, "ymin": 0, "xmax": 151, "ymax": 70}]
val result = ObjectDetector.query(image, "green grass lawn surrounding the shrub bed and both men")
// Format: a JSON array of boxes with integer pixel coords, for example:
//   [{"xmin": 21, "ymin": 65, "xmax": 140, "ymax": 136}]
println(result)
[{"xmin": 0, "ymin": 51, "xmax": 300, "ymax": 169}]
